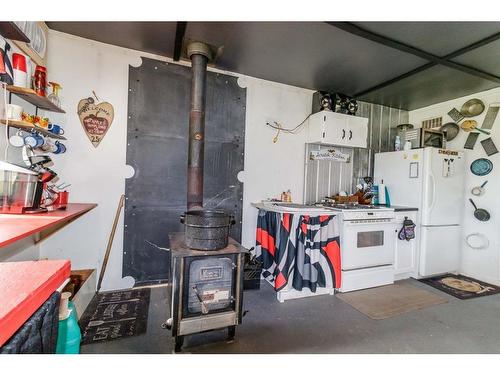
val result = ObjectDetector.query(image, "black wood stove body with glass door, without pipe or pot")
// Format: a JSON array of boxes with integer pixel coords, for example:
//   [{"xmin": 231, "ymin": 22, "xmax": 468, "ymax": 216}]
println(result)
[{"xmin": 165, "ymin": 233, "xmax": 247, "ymax": 352}]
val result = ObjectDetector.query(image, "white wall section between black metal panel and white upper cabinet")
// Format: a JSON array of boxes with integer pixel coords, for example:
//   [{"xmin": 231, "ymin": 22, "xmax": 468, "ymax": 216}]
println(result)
[{"xmin": 238, "ymin": 77, "xmax": 313, "ymax": 248}]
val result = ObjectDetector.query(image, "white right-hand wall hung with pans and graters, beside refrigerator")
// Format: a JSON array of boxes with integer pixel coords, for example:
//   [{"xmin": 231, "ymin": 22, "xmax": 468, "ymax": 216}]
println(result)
[{"xmin": 409, "ymin": 89, "xmax": 500, "ymax": 284}]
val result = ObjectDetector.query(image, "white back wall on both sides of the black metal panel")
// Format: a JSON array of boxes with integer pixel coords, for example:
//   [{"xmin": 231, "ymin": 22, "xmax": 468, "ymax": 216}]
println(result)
[{"xmin": 20, "ymin": 31, "xmax": 312, "ymax": 289}]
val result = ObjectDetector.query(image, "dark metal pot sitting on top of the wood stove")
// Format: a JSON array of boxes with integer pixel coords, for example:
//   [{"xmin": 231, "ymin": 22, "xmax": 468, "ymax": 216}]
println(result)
[{"xmin": 181, "ymin": 210, "xmax": 235, "ymax": 250}]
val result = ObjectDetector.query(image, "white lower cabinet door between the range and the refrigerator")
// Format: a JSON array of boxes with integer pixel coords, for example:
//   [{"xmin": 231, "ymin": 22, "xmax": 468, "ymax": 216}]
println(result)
[{"xmin": 394, "ymin": 212, "xmax": 418, "ymax": 279}]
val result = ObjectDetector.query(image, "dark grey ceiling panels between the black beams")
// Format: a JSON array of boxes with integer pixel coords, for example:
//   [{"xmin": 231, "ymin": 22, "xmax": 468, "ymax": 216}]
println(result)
[{"xmin": 48, "ymin": 22, "xmax": 500, "ymax": 110}]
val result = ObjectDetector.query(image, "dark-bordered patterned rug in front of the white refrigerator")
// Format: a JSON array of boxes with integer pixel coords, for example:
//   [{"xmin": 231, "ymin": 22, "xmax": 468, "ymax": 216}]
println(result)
[{"xmin": 420, "ymin": 273, "xmax": 500, "ymax": 299}]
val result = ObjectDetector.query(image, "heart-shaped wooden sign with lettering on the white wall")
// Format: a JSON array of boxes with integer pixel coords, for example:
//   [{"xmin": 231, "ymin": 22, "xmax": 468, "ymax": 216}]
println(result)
[{"xmin": 78, "ymin": 98, "xmax": 115, "ymax": 147}]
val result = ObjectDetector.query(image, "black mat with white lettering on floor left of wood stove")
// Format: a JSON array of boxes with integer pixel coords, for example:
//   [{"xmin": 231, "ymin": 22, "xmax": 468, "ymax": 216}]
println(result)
[{"xmin": 79, "ymin": 288, "xmax": 151, "ymax": 345}]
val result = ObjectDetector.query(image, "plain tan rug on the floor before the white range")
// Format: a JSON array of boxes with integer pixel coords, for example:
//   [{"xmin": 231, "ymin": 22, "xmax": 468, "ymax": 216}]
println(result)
[{"xmin": 336, "ymin": 283, "xmax": 448, "ymax": 320}]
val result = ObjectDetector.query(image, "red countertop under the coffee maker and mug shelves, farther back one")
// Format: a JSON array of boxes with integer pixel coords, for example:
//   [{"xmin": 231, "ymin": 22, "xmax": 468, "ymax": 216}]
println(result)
[{"xmin": 0, "ymin": 203, "xmax": 97, "ymax": 251}]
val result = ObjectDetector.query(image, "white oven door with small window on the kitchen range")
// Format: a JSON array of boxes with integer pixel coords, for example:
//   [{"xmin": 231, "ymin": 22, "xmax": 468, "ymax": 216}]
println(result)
[{"xmin": 341, "ymin": 219, "xmax": 396, "ymax": 271}]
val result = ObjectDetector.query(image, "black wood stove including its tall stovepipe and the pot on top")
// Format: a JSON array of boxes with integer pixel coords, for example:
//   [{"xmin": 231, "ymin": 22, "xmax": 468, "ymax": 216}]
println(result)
[{"xmin": 164, "ymin": 42, "xmax": 246, "ymax": 352}]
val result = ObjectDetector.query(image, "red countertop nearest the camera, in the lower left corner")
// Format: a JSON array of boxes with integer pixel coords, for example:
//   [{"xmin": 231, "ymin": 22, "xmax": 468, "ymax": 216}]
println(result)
[{"xmin": 0, "ymin": 260, "xmax": 71, "ymax": 346}]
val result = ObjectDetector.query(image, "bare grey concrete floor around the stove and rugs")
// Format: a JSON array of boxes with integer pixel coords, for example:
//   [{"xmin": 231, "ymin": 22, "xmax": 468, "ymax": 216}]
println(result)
[{"xmin": 81, "ymin": 280, "xmax": 500, "ymax": 353}]
